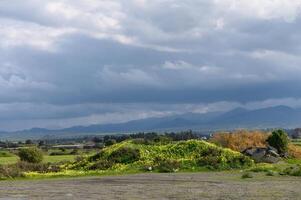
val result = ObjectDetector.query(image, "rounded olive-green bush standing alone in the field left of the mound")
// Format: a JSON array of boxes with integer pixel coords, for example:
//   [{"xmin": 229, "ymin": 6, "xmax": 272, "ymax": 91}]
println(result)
[{"xmin": 18, "ymin": 147, "xmax": 43, "ymax": 163}]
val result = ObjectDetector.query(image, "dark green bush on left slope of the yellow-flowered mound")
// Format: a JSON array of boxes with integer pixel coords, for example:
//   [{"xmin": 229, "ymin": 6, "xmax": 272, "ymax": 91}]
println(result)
[{"xmin": 108, "ymin": 147, "xmax": 140, "ymax": 164}]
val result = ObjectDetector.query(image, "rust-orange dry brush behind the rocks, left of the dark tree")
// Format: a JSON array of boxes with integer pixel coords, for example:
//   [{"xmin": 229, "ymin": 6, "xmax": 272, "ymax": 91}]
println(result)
[{"xmin": 211, "ymin": 130, "xmax": 269, "ymax": 151}]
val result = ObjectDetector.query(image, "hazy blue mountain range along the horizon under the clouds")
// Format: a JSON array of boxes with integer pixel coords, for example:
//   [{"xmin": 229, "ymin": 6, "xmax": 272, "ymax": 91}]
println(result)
[{"xmin": 0, "ymin": 106, "xmax": 301, "ymax": 140}]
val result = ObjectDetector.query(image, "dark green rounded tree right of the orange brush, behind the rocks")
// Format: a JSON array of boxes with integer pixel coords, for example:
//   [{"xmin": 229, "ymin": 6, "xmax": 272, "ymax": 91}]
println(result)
[{"xmin": 267, "ymin": 130, "xmax": 289, "ymax": 155}]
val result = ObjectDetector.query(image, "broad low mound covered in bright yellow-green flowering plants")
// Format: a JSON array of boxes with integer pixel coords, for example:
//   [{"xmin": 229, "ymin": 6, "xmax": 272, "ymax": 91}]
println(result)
[{"xmin": 68, "ymin": 140, "xmax": 253, "ymax": 172}]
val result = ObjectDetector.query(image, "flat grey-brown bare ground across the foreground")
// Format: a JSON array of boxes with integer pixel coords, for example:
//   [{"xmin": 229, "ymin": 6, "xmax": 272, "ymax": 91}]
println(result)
[{"xmin": 0, "ymin": 172, "xmax": 301, "ymax": 200}]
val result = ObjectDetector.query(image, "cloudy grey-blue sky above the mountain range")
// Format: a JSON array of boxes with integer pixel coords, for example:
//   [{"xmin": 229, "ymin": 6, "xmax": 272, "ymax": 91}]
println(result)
[{"xmin": 0, "ymin": 0, "xmax": 301, "ymax": 131}]
